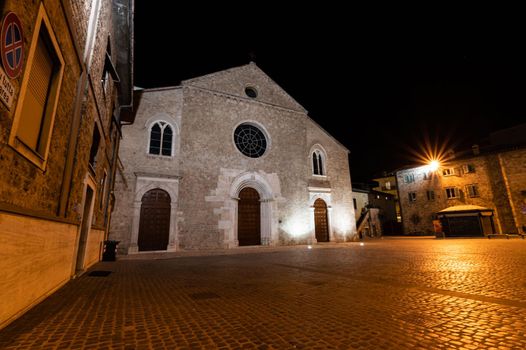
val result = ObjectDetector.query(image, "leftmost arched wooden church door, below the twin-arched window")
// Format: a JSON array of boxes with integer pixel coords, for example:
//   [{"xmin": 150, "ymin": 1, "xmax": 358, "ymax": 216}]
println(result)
[{"xmin": 137, "ymin": 189, "xmax": 170, "ymax": 251}]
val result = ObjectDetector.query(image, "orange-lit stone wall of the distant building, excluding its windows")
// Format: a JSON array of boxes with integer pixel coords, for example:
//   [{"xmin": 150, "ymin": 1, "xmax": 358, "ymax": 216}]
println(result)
[{"xmin": 397, "ymin": 149, "xmax": 526, "ymax": 233}]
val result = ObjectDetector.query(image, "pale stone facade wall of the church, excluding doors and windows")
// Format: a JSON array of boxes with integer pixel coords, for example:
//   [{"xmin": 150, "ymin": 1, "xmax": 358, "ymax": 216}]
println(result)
[{"xmin": 111, "ymin": 64, "xmax": 355, "ymax": 251}]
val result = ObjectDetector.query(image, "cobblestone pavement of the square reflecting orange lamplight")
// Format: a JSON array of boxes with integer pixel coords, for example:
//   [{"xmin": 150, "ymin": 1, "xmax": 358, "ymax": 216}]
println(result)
[{"xmin": 0, "ymin": 238, "xmax": 526, "ymax": 349}]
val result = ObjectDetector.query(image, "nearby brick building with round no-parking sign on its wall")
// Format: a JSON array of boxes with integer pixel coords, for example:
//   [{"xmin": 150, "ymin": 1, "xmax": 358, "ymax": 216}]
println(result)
[{"xmin": 0, "ymin": 0, "xmax": 133, "ymax": 328}]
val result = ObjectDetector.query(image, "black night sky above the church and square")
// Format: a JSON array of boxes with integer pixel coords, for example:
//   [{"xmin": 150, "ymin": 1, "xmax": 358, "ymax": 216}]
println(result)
[{"xmin": 135, "ymin": 5, "xmax": 526, "ymax": 182}]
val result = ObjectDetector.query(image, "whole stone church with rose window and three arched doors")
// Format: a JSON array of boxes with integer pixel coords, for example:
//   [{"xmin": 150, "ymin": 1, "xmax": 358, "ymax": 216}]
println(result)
[{"xmin": 110, "ymin": 63, "xmax": 356, "ymax": 253}]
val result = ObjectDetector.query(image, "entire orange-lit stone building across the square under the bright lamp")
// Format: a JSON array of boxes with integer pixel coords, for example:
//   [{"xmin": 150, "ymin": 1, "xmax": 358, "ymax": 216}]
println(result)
[{"xmin": 396, "ymin": 127, "xmax": 526, "ymax": 236}]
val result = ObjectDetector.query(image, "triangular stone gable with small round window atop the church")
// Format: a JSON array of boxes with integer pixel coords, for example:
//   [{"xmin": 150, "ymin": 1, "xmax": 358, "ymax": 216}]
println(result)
[{"xmin": 181, "ymin": 62, "xmax": 307, "ymax": 114}]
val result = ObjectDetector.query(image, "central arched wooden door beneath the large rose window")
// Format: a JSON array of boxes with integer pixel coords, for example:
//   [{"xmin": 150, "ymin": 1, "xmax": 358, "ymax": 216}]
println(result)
[{"xmin": 237, "ymin": 187, "xmax": 261, "ymax": 246}]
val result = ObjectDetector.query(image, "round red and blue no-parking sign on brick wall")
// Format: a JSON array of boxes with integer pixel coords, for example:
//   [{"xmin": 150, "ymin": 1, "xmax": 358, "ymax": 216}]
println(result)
[{"xmin": 0, "ymin": 12, "xmax": 24, "ymax": 79}]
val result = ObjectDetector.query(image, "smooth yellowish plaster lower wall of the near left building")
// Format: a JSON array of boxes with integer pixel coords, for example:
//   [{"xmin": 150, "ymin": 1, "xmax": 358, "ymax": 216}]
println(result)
[{"xmin": 0, "ymin": 213, "xmax": 77, "ymax": 328}]
